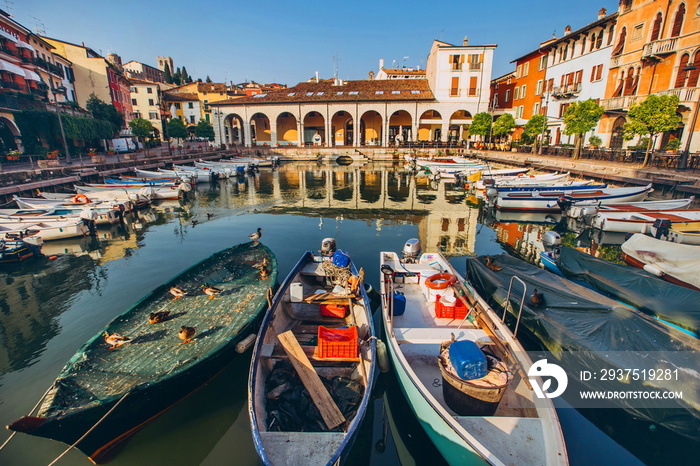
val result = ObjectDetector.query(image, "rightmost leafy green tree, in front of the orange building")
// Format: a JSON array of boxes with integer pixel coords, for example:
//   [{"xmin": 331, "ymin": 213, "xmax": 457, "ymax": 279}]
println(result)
[{"xmin": 624, "ymin": 94, "xmax": 681, "ymax": 167}]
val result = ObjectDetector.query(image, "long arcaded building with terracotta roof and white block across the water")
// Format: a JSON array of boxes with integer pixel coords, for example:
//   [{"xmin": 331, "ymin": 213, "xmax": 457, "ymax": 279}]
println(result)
[{"xmin": 213, "ymin": 38, "xmax": 496, "ymax": 147}]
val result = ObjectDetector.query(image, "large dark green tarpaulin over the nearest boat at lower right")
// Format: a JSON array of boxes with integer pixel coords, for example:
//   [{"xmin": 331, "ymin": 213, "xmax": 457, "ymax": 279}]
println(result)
[{"xmin": 467, "ymin": 254, "xmax": 700, "ymax": 440}]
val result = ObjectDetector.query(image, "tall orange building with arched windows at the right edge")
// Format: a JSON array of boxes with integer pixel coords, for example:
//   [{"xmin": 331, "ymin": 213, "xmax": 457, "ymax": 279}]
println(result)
[{"xmin": 599, "ymin": 0, "xmax": 700, "ymax": 151}]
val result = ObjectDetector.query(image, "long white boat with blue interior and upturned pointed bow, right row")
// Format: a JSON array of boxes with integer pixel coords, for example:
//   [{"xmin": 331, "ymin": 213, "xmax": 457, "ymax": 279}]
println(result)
[{"xmin": 495, "ymin": 184, "xmax": 652, "ymax": 212}]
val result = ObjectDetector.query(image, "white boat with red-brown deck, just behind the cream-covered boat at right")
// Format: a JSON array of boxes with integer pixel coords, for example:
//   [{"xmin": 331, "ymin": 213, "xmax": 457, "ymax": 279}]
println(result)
[{"xmin": 590, "ymin": 209, "xmax": 700, "ymax": 233}]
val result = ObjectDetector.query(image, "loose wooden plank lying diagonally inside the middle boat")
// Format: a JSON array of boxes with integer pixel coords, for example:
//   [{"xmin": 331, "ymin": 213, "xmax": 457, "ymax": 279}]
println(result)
[{"xmin": 277, "ymin": 330, "xmax": 345, "ymax": 429}]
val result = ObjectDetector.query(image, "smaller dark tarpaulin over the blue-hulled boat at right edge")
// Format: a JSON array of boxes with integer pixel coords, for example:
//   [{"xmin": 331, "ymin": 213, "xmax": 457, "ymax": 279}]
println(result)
[{"xmin": 557, "ymin": 246, "xmax": 700, "ymax": 333}]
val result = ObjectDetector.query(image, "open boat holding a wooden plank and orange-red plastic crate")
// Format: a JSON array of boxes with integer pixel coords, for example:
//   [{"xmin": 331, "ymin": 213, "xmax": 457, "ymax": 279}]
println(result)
[{"xmin": 248, "ymin": 246, "xmax": 376, "ymax": 466}]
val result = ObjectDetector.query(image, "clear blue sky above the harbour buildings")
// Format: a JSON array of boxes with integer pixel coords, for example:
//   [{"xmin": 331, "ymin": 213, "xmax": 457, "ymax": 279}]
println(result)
[{"xmin": 13, "ymin": 0, "xmax": 618, "ymax": 86}]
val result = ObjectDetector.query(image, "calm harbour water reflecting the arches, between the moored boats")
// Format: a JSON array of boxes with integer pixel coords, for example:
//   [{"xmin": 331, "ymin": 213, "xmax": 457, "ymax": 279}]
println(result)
[{"xmin": 0, "ymin": 164, "xmax": 698, "ymax": 465}]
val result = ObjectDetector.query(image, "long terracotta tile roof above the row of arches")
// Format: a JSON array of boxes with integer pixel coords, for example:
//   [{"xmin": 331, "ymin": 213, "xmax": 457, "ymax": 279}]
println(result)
[{"xmin": 209, "ymin": 79, "xmax": 435, "ymax": 106}]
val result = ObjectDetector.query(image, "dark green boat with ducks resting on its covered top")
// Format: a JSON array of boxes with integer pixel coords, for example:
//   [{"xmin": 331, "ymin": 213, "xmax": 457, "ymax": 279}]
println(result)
[{"xmin": 8, "ymin": 243, "xmax": 277, "ymax": 463}]
